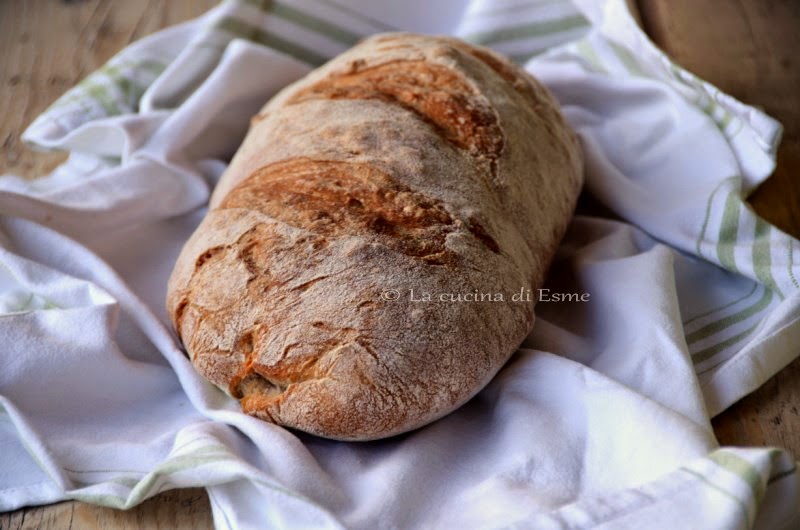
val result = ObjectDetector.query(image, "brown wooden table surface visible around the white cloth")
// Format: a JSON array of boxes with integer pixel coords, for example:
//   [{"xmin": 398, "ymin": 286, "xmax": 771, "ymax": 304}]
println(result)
[{"xmin": 0, "ymin": 0, "xmax": 800, "ymax": 529}]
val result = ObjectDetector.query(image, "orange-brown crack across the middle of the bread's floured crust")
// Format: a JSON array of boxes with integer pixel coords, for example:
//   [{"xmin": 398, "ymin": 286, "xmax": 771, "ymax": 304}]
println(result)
[{"xmin": 219, "ymin": 158, "xmax": 500, "ymax": 265}]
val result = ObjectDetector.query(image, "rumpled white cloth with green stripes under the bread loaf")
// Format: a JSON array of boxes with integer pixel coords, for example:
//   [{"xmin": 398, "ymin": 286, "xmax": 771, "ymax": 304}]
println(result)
[{"xmin": 0, "ymin": 0, "xmax": 800, "ymax": 529}]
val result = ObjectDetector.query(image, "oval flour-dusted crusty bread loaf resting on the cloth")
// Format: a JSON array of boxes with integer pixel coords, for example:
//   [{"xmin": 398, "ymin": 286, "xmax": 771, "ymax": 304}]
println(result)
[{"xmin": 167, "ymin": 33, "xmax": 582, "ymax": 440}]
